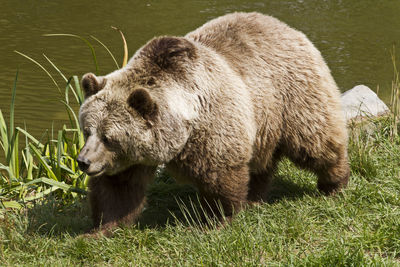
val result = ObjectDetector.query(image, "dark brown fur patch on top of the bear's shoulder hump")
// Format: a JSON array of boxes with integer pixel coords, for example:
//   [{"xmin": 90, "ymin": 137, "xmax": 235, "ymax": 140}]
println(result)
[{"xmin": 143, "ymin": 37, "xmax": 197, "ymax": 70}]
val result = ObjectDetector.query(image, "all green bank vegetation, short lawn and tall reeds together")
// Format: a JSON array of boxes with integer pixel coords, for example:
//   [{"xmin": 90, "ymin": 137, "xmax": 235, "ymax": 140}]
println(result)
[{"xmin": 0, "ymin": 35, "xmax": 400, "ymax": 266}]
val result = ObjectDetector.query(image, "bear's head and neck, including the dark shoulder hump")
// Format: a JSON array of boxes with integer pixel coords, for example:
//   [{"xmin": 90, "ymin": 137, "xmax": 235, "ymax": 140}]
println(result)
[{"xmin": 77, "ymin": 37, "xmax": 200, "ymax": 176}]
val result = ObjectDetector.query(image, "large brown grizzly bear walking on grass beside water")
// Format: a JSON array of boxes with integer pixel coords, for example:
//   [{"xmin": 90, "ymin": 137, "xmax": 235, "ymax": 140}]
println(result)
[{"xmin": 77, "ymin": 13, "xmax": 349, "ymax": 232}]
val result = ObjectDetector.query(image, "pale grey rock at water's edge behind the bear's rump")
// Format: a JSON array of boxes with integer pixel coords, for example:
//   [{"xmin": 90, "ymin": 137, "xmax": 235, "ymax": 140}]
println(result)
[{"xmin": 341, "ymin": 85, "xmax": 389, "ymax": 120}]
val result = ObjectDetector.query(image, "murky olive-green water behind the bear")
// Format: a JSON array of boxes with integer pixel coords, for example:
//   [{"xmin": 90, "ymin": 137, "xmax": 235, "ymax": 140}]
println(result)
[{"xmin": 0, "ymin": 0, "xmax": 400, "ymax": 140}]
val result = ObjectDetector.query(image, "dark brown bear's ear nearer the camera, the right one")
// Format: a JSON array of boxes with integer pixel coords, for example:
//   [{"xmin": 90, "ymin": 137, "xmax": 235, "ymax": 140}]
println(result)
[{"xmin": 128, "ymin": 89, "xmax": 158, "ymax": 121}]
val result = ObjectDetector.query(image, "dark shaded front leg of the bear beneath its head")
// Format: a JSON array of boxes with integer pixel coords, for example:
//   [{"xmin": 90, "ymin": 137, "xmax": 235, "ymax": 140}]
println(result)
[{"xmin": 89, "ymin": 166, "xmax": 156, "ymax": 233}]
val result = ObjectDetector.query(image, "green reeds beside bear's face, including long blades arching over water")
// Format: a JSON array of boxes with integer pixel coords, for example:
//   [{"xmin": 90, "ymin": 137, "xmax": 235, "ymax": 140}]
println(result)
[{"xmin": 0, "ymin": 28, "xmax": 128, "ymax": 212}]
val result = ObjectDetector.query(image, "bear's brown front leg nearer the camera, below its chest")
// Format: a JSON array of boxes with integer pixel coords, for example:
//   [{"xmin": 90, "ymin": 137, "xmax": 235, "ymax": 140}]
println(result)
[{"xmin": 198, "ymin": 165, "xmax": 250, "ymax": 222}]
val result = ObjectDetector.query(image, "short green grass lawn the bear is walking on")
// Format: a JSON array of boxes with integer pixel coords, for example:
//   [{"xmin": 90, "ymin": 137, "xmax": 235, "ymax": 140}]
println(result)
[{"xmin": 0, "ymin": 118, "xmax": 400, "ymax": 266}]
